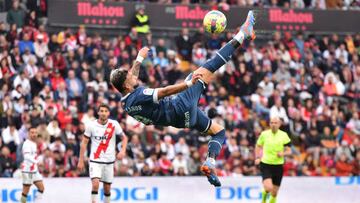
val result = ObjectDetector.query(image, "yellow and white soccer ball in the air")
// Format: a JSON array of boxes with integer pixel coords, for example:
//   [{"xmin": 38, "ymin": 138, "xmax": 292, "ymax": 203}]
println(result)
[{"xmin": 203, "ymin": 10, "xmax": 227, "ymax": 34}]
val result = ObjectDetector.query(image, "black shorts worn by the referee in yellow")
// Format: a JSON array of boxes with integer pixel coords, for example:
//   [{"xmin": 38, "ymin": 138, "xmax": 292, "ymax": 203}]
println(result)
[{"xmin": 260, "ymin": 162, "xmax": 284, "ymax": 186}]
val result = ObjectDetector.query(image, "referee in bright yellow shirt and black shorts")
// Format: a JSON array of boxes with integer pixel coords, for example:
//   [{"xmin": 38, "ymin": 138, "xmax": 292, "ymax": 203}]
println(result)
[{"xmin": 255, "ymin": 117, "xmax": 291, "ymax": 203}]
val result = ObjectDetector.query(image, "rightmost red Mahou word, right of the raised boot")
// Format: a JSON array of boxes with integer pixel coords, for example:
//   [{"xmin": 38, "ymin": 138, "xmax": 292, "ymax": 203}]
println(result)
[{"xmin": 269, "ymin": 9, "xmax": 314, "ymax": 24}]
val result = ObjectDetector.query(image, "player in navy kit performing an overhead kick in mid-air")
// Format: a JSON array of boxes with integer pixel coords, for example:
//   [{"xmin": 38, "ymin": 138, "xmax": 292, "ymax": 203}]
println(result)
[{"xmin": 110, "ymin": 11, "xmax": 255, "ymax": 187}]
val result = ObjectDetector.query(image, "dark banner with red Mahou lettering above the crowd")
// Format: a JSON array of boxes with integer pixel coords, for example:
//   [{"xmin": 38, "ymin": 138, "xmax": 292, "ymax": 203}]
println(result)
[{"xmin": 49, "ymin": 0, "xmax": 360, "ymax": 33}]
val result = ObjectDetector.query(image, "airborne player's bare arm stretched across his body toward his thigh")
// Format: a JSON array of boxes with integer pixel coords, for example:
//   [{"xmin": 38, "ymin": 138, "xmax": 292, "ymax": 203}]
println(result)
[{"xmin": 156, "ymin": 74, "xmax": 202, "ymax": 99}]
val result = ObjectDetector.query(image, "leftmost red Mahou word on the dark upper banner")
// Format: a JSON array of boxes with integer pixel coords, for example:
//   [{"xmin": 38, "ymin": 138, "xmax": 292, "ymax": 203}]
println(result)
[{"xmin": 77, "ymin": 2, "xmax": 125, "ymax": 17}]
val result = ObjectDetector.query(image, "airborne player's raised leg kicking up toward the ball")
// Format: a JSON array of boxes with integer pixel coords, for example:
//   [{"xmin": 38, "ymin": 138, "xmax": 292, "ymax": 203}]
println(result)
[{"xmin": 195, "ymin": 10, "xmax": 256, "ymax": 83}]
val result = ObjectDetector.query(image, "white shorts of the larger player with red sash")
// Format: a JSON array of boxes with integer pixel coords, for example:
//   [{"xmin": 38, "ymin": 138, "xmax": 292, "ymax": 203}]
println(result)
[{"xmin": 89, "ymin": 162, "xmax": 114, "ymax": 184}]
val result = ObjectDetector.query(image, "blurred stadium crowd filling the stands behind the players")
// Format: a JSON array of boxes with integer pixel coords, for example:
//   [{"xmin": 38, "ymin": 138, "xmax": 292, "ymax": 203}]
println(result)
[{"xmin": 0, "ymin": 0, "xmax": 360, "ymax": 177}]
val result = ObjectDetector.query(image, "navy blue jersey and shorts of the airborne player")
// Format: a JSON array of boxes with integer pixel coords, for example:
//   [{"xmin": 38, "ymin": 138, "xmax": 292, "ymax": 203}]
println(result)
[{"xmin": 121, "ymin": 83, "xmax": 209, "ymax": 130}]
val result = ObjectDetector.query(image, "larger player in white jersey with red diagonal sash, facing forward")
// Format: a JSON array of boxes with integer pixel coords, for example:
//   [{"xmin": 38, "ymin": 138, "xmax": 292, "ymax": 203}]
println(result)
[{"xmin": 78, "ymin": 104, "xmax": 128, "ymax": 203}]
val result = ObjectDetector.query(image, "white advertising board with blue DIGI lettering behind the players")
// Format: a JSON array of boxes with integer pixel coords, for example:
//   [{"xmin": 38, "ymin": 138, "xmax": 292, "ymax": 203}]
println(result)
[{"xmin": 0, "ymin": 177, "xmax": 360, "ymax": 203}]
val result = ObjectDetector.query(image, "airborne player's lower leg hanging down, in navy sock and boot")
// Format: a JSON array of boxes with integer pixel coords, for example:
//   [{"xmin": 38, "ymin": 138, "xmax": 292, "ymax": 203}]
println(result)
[{"xmin": 200, "ymin": 123, "xmax": 225, "ymax": 187}]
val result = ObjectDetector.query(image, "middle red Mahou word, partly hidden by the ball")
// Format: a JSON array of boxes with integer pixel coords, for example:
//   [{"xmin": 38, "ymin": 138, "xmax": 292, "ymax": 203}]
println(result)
[{"xmin": 175, "ymin": 6, "xmax": 209, "ymax": 20}]
